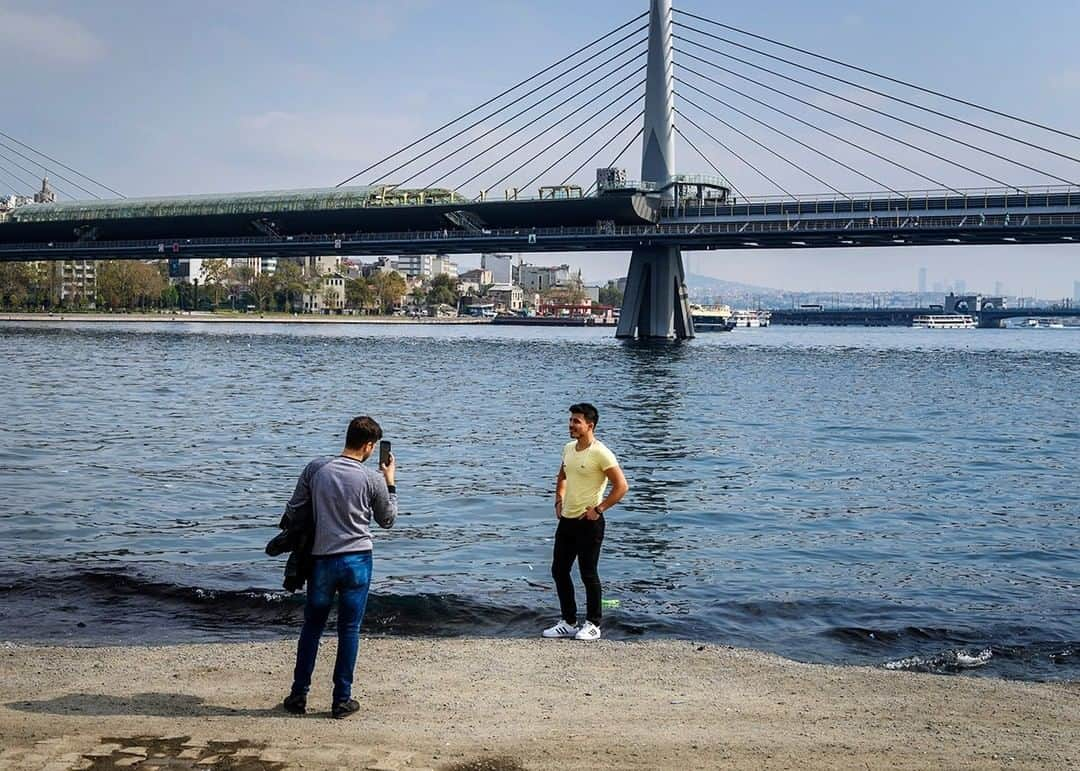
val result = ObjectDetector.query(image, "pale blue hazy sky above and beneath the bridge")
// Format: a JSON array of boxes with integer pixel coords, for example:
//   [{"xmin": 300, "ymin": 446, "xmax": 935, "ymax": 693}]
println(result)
[{"xmin": 0, "ymin": 0, "xmax": 1080, "ymax": 298}]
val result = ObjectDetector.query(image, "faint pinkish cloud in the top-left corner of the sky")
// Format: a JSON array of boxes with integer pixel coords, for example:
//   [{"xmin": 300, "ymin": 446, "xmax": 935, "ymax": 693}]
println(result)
[{"xmin": 0, "ymin": 8, "xmax": 106, "ymax": 65}]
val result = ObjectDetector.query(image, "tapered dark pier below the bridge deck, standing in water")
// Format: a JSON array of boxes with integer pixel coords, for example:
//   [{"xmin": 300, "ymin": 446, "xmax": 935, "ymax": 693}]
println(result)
[{"xmin": 616, "ymin": 246, "xmax": 693, "ymax": 340}]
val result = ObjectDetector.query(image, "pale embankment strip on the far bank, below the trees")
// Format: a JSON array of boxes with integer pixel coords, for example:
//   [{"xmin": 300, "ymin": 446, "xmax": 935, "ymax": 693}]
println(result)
[{"xmin": 0, "ymin": 311, "xmax": 491, "ymax": 326}]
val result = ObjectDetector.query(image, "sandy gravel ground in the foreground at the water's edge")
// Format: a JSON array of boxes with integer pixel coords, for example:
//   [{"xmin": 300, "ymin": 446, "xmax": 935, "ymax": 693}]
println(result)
[{"xmin": 0, "ymin": 638, "xmax": 1080, "ymax": 771}]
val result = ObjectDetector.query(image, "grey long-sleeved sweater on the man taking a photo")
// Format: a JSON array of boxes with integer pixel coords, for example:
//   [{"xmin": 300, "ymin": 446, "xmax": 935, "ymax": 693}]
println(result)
[{"xmin": 285, "ymin": 456, "xmax": 397, "ymax": 557}]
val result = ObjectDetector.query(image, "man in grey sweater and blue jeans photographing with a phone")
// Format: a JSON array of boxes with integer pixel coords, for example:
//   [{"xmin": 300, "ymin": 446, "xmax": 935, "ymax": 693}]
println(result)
[{"xmin": 285, "ymin": 416, "xmax": 397, "ymax": 718}]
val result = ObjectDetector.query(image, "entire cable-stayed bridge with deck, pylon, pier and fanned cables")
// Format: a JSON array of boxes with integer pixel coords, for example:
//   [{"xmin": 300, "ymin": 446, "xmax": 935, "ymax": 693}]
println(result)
[{"xmin": 0, "ymin": 0, "xmax": 1080, "ymax": 338}]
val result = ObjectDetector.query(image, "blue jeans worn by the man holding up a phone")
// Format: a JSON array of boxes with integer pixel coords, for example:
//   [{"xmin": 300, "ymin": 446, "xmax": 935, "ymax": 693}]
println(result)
[{"xmin": 293, "ymin": 552, "xmax": 372, "ymax": 704}]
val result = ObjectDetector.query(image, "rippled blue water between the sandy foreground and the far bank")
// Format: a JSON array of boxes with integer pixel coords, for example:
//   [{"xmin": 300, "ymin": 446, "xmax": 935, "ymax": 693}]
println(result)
[{"xmin": 0, "ymin": 323, "xmax": 1080, "ymax": 679}]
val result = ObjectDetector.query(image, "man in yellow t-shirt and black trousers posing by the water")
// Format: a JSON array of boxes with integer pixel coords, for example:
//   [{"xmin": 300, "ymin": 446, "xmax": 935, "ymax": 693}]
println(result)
[{"xmin": 543, "ymin": 403, "xmax": 630, "ymax": 640}]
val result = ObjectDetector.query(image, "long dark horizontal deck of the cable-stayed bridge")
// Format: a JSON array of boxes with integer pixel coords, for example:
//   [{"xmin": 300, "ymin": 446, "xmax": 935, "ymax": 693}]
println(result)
[{"xmin": 6, "ymin": 189, "xmax": 1080, "ymax": 260}]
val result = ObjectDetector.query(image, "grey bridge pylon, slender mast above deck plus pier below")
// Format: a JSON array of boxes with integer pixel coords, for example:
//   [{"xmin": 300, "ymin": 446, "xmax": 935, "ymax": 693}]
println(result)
[{"xmin": 616, "ymin": 0, "xmax": 693, "ymax": 340}]
